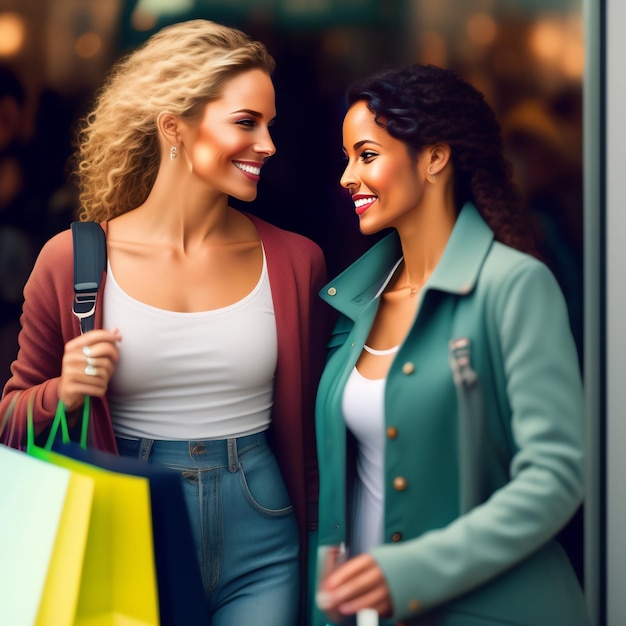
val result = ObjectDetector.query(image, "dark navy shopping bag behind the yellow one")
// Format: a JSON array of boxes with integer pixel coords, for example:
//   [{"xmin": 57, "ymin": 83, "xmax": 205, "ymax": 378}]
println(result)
[{"xmin": 53, "ymin": 442, "xmax": 211, "ymax": 626}]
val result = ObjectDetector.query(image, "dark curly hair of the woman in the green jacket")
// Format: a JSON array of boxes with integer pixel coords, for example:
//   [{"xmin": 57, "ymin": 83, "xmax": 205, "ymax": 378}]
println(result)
[{"xmin": 346, "ymin": 65, "xmax": 536, "ymax": 255}]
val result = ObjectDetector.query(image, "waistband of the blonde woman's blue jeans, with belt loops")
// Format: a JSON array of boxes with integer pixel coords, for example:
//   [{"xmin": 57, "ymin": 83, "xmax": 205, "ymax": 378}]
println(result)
[{"xmin": 118, "ymin": 431, "xmax": 267, "ymax": 472}]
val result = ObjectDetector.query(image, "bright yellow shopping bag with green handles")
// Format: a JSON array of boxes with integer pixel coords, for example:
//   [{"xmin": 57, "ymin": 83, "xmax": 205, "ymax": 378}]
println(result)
[{"xmin": 27, "ymin": 400, "xmax": 159, "ymax": 626}]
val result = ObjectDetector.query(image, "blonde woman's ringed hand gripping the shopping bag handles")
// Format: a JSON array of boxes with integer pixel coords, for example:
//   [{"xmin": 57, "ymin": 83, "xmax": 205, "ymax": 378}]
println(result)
[{"xmin": 59, "ymin": 328, "xmax": 122, "ymax": 412}]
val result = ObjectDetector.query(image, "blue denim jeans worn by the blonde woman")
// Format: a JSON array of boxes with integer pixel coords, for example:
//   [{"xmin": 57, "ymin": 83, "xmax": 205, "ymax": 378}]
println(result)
[{"xmin": 117, "ymin": 433, "xmax": 300, "ymax": 626}]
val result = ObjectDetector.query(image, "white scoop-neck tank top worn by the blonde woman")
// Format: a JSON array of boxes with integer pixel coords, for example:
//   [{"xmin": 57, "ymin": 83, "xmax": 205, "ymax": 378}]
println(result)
[{"xmin": 103, "ymin": 251, "xmax": 277, "ymax": 440}]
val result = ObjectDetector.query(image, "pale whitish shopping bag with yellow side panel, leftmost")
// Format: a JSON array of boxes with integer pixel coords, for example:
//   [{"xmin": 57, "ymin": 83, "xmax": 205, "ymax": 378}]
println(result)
[{"xmin": 0, "ymin": 444, "xmax": 93, "ymax": 626}]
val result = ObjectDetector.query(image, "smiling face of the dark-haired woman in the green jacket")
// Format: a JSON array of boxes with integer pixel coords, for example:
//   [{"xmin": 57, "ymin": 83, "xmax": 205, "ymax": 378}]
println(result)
[{"xmin": 341, "ymin": 101, "xmax": 426, "ymax": 234}]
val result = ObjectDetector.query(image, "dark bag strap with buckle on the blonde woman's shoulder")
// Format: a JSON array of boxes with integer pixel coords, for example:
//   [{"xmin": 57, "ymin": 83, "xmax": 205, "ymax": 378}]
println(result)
[{"xmin": 71, "ymin": 222, "xmax": 107, "ymax": 333}]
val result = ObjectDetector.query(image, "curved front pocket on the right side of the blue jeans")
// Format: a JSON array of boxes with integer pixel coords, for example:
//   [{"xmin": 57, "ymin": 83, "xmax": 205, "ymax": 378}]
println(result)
[{"xmin": 239, "ymin": 444, "xmax": 293, "ymax": 517}]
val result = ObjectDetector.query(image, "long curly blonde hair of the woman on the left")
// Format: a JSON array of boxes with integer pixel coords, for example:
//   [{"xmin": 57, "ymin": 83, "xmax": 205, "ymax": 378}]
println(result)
[{"xmin": 74, "ymin": 19, "xmax": 275, "ymax": 221}]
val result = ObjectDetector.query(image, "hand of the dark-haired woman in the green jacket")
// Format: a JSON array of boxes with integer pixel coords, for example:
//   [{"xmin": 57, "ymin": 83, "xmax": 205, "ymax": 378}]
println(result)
[{"xmin": 317, "ymin": 554, "xmax": 392, "ymax": 621}]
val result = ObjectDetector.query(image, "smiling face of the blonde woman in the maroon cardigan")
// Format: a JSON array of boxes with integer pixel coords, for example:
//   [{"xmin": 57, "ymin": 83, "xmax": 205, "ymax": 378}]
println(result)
[{"xmin": 187, "ymin": 69, "xmax": 276, "ymax": 201}]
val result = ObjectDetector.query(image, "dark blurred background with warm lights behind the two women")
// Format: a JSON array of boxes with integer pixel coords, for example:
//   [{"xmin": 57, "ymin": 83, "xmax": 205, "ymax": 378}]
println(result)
[{"xmin": 0, "ymin": 0, "xmax": 584, "ymax": 578}]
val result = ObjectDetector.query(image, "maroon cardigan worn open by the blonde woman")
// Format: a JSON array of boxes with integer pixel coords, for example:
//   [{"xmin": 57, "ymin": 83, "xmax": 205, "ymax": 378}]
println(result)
[{"xmin": 0, "ymin": 215, "xmax": 330, "ymax": 560}]
